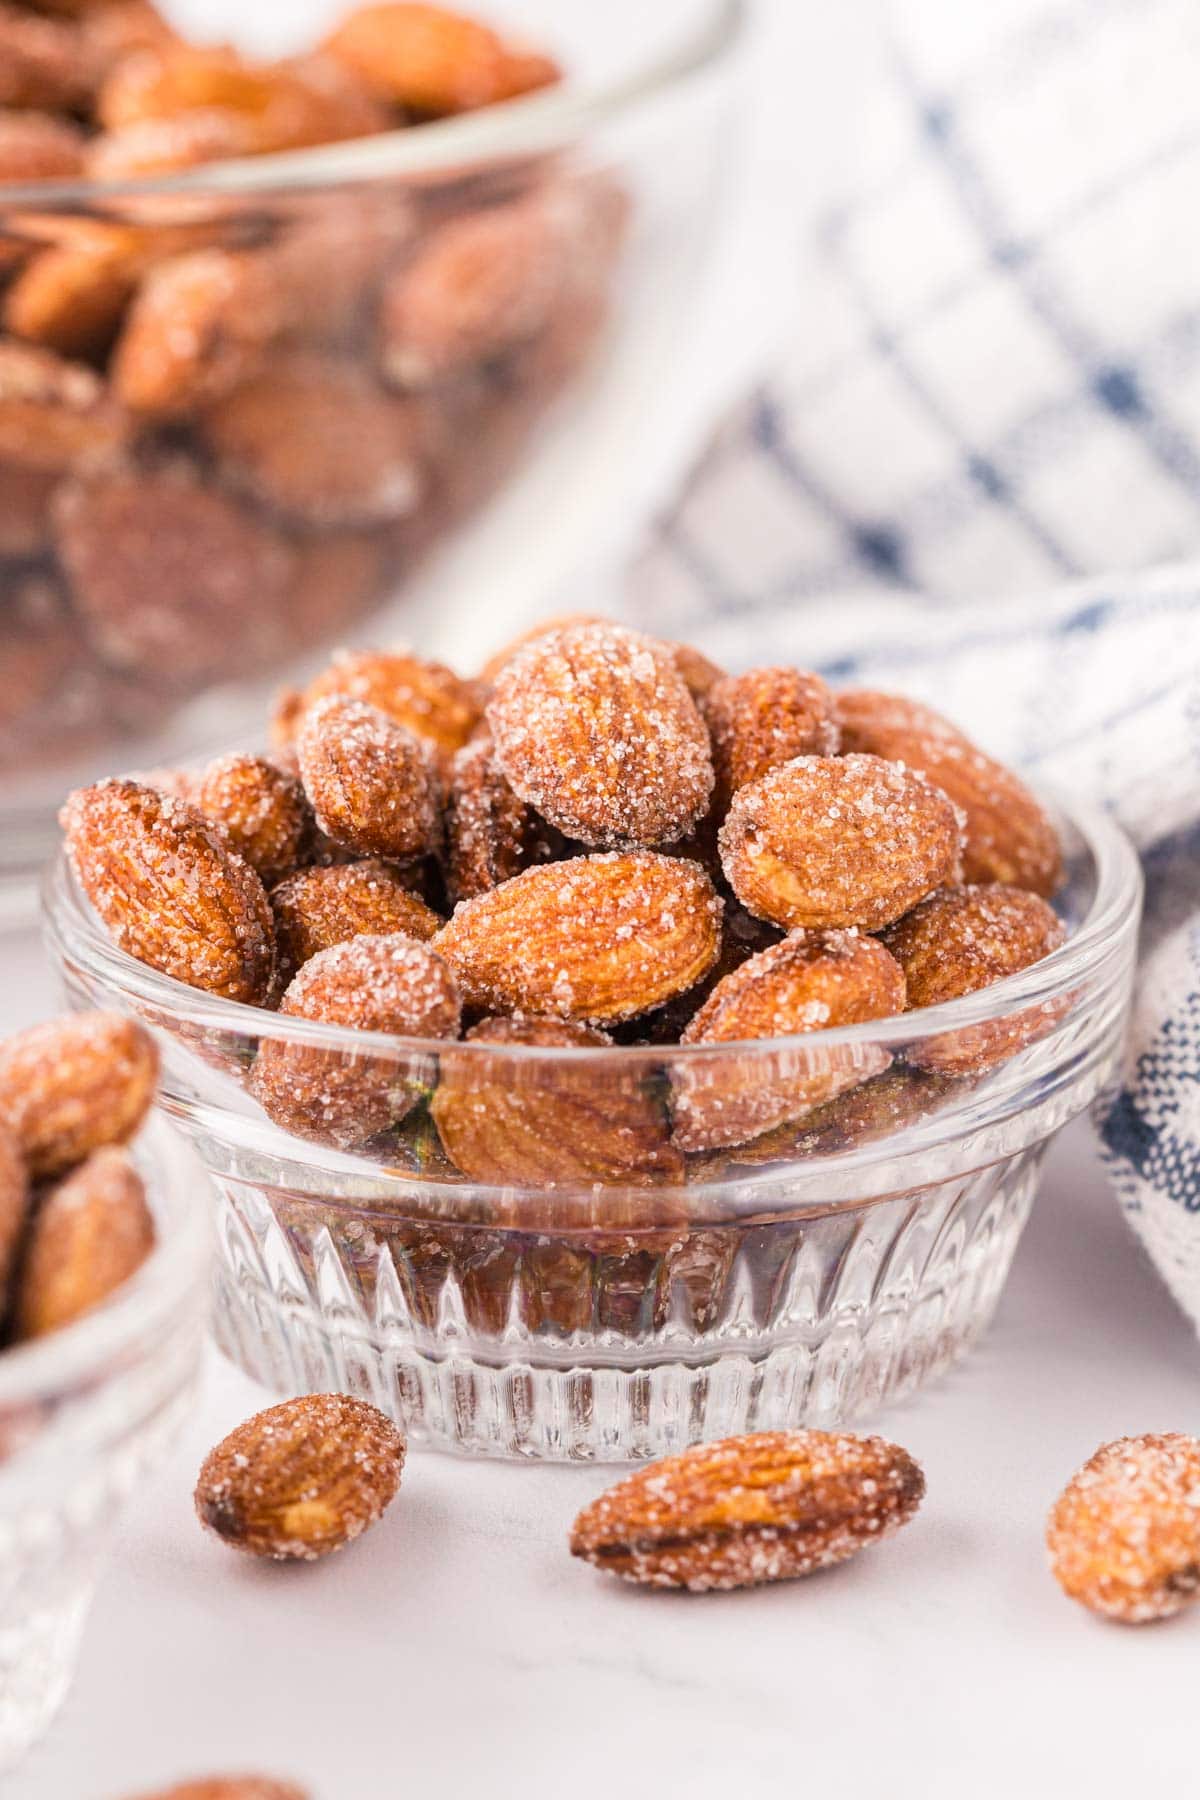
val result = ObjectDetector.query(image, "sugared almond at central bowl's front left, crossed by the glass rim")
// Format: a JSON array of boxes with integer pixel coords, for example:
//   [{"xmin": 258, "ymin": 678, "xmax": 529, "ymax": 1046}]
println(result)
[{"xmin": 250, "ymin": 934, "xmax": 462, "ymax": 1148}]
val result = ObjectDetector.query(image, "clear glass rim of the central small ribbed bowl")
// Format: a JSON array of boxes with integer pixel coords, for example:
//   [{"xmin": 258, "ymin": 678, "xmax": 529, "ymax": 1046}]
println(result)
[{"xmin": 41, "ymin": 790, "xmax": 1142, "ymax": 1080}]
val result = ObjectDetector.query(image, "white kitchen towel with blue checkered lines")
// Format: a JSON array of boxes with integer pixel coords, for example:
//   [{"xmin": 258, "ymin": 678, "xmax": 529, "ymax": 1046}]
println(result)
[{"xmin": 633, "ymin": 0, "xmax": 1200, "ymax": 1323}]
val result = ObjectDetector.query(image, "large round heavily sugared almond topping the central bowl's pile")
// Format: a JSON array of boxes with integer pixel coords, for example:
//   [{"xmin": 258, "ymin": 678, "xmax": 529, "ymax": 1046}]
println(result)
[{"xmin": 488, "ymin": 625, "xmax": 712, "ymax": 848}]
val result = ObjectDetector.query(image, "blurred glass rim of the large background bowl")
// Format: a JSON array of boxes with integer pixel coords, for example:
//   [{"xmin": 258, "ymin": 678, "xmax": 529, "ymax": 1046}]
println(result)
[{"xmin": 0, "ymin": 0, "xmax": 750, "ymax": 209}]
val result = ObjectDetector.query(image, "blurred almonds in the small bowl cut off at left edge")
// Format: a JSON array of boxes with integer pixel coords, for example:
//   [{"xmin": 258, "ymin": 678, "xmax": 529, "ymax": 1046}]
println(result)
[{"xmin": 0, "ymin": 1013, "xmax": 158, "ymax": 1345}]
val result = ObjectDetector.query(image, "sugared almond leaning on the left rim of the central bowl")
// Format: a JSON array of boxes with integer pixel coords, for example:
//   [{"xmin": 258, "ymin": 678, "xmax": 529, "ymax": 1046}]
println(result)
[{"xmin": 61, "ymin": 779, "xmax": 275, "ymax": 1006}]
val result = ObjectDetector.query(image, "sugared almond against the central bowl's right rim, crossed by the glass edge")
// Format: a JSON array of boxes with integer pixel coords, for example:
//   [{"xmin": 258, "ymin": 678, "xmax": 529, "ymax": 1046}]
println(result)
[{"xmin": 883, "ymin": 882, "xmax": 1067, "ymax": 1075}]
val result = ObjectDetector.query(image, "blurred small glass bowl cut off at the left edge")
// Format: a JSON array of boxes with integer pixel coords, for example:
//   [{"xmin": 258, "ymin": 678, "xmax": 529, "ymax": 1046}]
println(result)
[{"xmin": 0, "ymin": 1118, "xmax": 212, "ymax": 1771}]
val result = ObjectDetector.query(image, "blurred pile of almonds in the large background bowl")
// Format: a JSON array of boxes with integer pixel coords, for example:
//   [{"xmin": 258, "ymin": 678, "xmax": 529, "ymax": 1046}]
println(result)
[{"xmin": 0, "ymin": 0, "xmax": 626, "ymax": 767}]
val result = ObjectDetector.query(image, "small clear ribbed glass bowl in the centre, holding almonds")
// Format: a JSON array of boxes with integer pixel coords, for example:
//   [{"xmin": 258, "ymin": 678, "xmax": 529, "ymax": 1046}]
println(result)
[{"xmin": 45, "ymin": 810, "xmax": 1141, "ymax": 1460}]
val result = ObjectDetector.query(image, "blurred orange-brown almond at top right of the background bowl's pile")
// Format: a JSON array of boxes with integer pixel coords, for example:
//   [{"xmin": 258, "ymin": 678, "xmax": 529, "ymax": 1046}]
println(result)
[{"xmin": 326, "ymin": 0, "xmax": 560, "ymax": 117}]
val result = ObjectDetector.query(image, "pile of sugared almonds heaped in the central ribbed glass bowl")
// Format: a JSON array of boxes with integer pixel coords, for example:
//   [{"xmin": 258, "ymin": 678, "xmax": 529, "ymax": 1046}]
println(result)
[{"xmin": 63, "ymin": 617, "xmax": 1063, "ymax": 1188}]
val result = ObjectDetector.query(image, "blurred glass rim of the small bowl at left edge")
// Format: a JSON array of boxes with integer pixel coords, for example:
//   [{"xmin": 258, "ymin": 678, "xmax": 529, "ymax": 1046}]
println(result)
[{"xmin": 0, "ymin": 1109, "xmax": 210, "ymax": 1411}]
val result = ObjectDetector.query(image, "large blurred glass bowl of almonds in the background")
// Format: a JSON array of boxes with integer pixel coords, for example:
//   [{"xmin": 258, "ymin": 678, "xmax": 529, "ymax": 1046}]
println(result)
[{"xmin": 0, "ymin": 0, "xmax": 741, "ymax": 904}]
